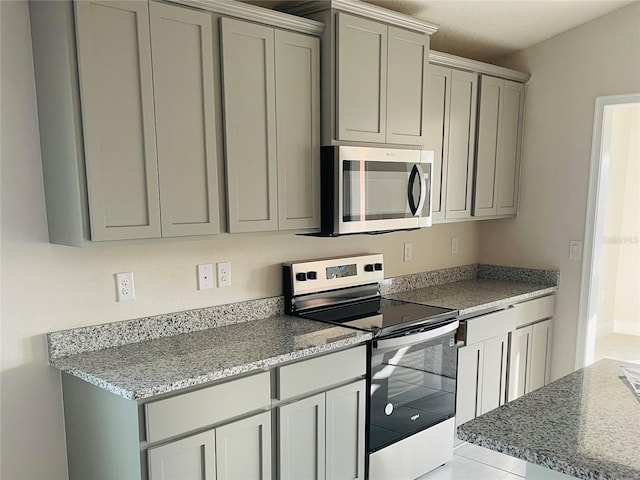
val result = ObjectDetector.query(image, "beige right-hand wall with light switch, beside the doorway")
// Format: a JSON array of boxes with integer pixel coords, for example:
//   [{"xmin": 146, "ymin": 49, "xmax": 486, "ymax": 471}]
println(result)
[{"xmin": 480, "ymin": 3, "xmax": 640, "ymax": 378}]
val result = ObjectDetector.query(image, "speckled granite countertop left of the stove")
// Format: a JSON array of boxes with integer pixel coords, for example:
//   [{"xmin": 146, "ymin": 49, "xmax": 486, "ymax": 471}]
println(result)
[{"xmin": 49, "ymin": 316, "xmax": 371, "ymax": 400}]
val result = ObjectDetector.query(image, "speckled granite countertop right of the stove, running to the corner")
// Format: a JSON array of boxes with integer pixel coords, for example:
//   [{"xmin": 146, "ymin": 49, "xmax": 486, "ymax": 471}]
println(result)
[{"xmin": 386, "ymin": 278, "xmax": 558, "ymax": 316}]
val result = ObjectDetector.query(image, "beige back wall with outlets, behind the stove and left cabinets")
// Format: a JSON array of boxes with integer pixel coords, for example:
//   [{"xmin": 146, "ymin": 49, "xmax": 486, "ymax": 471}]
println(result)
[{"xmin": 0, "ymin": 1, "xmax": 479, "ymax": 480}]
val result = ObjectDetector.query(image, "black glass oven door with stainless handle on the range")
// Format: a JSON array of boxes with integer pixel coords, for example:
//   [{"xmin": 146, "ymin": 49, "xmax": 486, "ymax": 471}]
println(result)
[{"xmin": 369, "ymin": 320, "xmax": 458, "ymax": 453}]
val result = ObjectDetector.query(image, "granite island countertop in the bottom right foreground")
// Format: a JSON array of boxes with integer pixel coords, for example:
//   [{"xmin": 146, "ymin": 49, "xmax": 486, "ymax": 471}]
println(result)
[{"xmin": 458, "ymin": 360, "xmax": 640, "ymax": 480}]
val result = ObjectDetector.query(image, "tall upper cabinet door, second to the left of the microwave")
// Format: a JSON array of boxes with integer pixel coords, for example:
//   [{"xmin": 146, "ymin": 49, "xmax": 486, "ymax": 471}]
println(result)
[{"xmin": 221, "ymin": 18, "xmax": 278, "ymax": 232}]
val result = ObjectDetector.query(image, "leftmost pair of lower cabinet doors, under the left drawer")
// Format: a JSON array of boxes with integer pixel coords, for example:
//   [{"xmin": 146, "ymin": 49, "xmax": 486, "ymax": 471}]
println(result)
[{"xmin": 147, "ymin": 412, "xmax": 271, "ymax": 480}]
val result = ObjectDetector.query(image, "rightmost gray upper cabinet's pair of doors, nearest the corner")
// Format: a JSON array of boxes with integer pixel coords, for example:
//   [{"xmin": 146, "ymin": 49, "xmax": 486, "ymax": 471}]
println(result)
[{"xmin": 473, "ymin": 75, "xmax": 524, "ymax": 217}]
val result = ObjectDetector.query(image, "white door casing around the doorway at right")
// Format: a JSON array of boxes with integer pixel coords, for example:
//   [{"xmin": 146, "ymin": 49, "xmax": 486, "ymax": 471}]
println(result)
[{"xmin": 575, "ymin": 93, "xmax": 640, "ymax": 369}]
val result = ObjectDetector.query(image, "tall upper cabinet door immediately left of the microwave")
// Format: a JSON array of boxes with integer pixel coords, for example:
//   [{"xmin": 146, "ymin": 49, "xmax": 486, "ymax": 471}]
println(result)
[{"xmin": 275, "ymin": 30, "xmax": 320, "ymax": 230}]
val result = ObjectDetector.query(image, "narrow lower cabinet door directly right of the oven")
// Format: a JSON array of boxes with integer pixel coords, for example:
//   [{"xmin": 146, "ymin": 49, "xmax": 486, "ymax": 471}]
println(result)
[{"xmin": 456, "ymin": 342, "xmax": 484, "ymax": 426}]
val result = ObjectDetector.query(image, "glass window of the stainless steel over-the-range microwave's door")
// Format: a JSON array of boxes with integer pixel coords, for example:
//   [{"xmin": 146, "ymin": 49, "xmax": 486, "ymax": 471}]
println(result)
[{"xmin": 342, "ymin": 160, "xmax": 420, "ymax": 222}]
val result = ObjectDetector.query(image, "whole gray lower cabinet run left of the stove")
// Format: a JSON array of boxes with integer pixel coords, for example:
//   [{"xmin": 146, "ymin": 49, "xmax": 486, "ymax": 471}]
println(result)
[{"xmin": 62, "ymin": 345, "xmax": 367, "ymax": 480}]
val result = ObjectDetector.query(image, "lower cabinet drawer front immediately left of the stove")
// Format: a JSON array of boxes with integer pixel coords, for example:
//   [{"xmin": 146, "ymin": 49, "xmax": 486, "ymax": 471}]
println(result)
[{"xmin": 278, "ymin": 345, "xmax": 367, "ymax": 400}]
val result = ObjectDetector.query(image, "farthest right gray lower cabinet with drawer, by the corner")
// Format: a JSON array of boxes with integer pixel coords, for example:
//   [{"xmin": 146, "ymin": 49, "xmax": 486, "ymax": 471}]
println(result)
[{"xmin": 507, "ymin": 295, "xmax": 555, "ymax": 401}]
